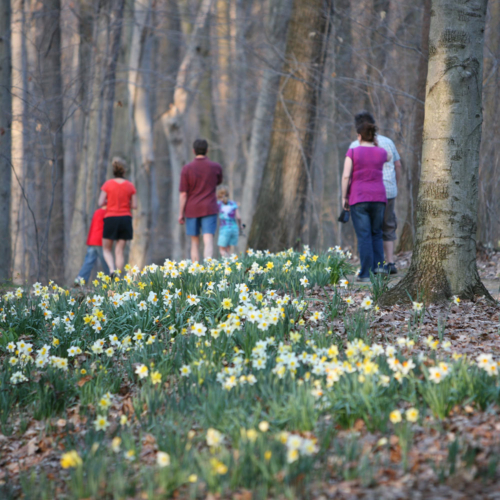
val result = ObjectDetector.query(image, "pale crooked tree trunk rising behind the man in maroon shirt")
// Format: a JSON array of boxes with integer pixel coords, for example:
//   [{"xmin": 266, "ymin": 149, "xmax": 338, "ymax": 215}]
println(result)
[{"xmin": 161, "ymin": 0, "xmax": 213, "ymax": 259}]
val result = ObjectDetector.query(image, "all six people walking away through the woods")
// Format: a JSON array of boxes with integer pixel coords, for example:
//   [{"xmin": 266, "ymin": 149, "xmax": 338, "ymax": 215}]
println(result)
[{"xmin": 76, "ymin": 111, "xmax": 401, "ymax": 283}]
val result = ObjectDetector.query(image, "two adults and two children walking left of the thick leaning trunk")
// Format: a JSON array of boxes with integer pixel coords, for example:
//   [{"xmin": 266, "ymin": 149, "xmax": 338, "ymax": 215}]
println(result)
[{"xmin": 75, "ymin": 139, "xmax": 243, "ymax": 284}]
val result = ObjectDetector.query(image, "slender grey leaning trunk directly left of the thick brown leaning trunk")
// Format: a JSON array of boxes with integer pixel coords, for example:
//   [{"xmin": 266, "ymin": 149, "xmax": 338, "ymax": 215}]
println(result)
[{"xmin": 240, "ymin": 0, "xmax": 293, "ymax": 242}]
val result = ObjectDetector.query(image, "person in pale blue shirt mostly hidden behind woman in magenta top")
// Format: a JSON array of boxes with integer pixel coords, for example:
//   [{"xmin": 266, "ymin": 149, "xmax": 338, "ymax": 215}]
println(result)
[{"xmin": 349, "ymin": 111, "xmax": 402, "ymax": 274}]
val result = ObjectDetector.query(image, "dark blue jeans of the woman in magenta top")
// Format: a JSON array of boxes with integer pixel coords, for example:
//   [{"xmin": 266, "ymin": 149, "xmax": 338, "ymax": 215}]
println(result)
[{"xmin": 351, "ymin": 201, "xmax": 385, "ymax": 278}]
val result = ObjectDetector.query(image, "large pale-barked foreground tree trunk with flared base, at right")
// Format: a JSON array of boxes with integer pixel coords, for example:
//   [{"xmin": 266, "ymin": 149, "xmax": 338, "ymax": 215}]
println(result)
[{"xmin": 381, "ymin": 0, "xmax": 489, "ymax": 304}]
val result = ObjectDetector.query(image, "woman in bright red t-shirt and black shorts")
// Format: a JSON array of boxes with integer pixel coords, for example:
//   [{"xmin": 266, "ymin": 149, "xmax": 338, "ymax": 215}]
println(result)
[{"xmin": 99, "ymin": 157, "xmax": 137, "ymax": 274}]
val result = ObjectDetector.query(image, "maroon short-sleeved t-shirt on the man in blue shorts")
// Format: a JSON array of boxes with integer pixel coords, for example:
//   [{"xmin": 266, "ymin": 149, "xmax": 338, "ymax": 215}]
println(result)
[{"xmin": 179, "ymin": 156, "xmax": 222, "ymax": 218}]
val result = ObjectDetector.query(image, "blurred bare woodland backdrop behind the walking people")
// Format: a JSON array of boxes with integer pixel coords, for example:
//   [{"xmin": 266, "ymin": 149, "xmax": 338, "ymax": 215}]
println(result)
[{"xmin": 0, "ymin": 0, "xmax": 500, "ymax": 284}]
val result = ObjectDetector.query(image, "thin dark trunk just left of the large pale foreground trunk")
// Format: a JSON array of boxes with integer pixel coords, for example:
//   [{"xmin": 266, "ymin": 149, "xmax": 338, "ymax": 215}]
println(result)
[{"xmin": 397, "ymin": 0, "xmax": 431, "ymax": 252}]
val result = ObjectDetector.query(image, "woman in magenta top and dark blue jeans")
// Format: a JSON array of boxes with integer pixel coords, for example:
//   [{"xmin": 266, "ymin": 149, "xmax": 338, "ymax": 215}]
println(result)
[{"xmin": 342, "ymin": 123, "xmax": 391, "ymax": 282}]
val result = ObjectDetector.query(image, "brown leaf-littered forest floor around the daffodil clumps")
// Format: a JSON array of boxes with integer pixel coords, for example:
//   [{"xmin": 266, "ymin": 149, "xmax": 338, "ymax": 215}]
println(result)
[{"xmin": 0, "ymin": 253, "xmax": 500, "ymax": 500}]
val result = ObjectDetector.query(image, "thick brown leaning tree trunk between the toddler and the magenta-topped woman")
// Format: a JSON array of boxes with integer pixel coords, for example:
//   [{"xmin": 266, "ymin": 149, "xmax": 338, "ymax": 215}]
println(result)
[{"xmin": 248, "ymin": 0, "xmax": 333, "ymax": 251}]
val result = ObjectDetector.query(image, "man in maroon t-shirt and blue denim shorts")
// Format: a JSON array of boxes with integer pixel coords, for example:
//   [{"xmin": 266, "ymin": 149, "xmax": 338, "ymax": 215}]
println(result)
[{"xmin": 179, "ymin": 139, "xmax": 222, "ymax": 262}]
